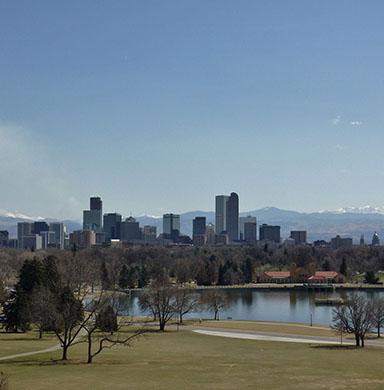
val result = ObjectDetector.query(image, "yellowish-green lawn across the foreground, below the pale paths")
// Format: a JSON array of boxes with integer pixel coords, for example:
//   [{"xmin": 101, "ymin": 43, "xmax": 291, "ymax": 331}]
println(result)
[{"xmin": 0, "ymin": 331, "xmax": 384, "ymax": 390}]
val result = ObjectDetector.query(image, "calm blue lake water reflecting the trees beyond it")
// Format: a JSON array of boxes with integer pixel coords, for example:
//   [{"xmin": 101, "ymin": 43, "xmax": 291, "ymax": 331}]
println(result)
[{"xmin": 124, "ymin": 288, "xmax": 384, "ymax": 325}]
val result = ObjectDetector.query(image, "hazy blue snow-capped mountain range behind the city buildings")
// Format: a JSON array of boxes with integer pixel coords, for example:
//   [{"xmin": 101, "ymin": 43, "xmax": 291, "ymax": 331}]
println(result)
[{"xmin": 0, "ymin": 206, "xmax": 384, "ymax": 242}]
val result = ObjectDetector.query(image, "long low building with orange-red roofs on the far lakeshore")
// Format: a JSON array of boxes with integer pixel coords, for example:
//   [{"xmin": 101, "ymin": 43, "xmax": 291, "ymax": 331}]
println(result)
[{"xmin": 258, "ymin": 271, "xmax": 345, "ymax": 284}]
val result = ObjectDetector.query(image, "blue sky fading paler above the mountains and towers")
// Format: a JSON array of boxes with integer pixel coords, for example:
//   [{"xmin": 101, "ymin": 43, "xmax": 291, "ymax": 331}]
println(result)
[{"xmin": 0, "ymin": 0, "xmax": 384, "ymax": 218}]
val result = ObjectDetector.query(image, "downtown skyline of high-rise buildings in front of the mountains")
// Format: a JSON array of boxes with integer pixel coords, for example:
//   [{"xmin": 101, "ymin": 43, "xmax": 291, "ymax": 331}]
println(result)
[{"xmin": 0, "ymin": 192, "xmax": 380, "ymax": 250}]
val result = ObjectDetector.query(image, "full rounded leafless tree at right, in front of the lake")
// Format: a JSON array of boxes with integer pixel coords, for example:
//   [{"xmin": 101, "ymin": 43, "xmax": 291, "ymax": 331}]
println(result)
[{"xmin": 332, "ymin": 294, "xmax": 373, "ymax": 347}]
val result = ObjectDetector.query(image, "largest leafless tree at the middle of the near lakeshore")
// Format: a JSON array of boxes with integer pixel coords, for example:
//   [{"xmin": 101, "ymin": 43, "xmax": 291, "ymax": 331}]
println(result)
[{"xmin": 139, "ymin": 279, "xmax": 176, "ymax": 331}]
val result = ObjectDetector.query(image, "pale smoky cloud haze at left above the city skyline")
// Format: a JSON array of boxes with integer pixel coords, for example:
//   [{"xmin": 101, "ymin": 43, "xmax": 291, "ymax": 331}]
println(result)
[{"xmin": 0, "ymin": 123, "xmax": 79, "ymax": 218}]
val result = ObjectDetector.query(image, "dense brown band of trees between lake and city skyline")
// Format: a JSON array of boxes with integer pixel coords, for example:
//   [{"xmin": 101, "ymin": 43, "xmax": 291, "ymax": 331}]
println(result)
[{"xmin": 0, "ymin": 245, "xmax": 384, "ymax": 289}]
